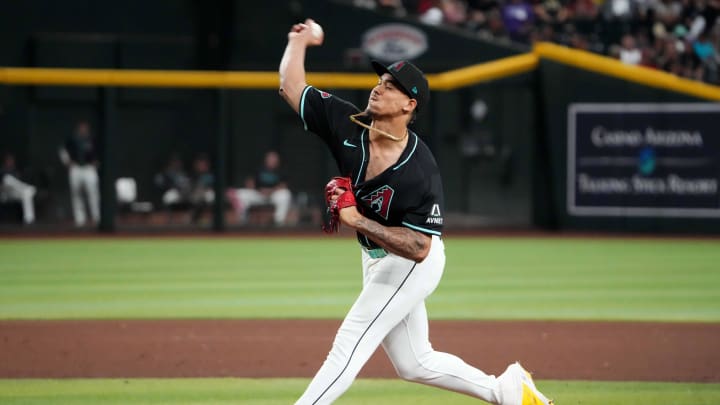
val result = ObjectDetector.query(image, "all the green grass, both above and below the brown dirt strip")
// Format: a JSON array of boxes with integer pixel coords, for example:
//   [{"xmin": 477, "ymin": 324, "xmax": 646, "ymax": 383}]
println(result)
[{"xmin": 0, "ymin": 238, "xmax": 720, "ymax": 405}]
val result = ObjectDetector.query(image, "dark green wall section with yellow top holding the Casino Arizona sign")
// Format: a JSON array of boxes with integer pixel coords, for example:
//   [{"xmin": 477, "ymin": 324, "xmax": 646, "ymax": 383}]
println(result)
[{"xmin": 534, "ymin": 44, "xmax": 720, "ymax": 233}]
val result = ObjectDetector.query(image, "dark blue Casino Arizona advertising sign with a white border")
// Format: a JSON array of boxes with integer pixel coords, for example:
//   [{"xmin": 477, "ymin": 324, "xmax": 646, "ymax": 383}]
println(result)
[{"xmin": 567, "ymin": 103, "xmax": 720, "ymax": 217}]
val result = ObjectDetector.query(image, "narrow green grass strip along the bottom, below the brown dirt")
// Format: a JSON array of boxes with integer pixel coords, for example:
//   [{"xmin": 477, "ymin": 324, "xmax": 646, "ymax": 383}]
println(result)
[{"xmin": 0, "ymin": 379, "xmax": 720, "ymax": 405}]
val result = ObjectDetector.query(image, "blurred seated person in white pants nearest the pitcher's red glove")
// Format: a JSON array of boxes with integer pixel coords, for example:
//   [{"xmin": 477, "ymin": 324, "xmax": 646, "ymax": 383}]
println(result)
[{"xmin": 227, "ymin": 150, "xmax": 292, "ymax": 226}]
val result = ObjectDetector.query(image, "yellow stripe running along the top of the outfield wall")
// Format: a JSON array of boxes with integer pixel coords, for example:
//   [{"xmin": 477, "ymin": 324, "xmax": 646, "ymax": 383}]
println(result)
[{"xmin": 0, "ymin": 42, "xmax": 720, "ymax": 100}]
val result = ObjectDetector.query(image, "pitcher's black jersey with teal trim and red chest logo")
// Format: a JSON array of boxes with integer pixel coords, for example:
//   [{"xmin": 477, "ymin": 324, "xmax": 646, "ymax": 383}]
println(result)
[{"xmin": 299, "ymin": 86, "xmax": 444, "ymax": 249}]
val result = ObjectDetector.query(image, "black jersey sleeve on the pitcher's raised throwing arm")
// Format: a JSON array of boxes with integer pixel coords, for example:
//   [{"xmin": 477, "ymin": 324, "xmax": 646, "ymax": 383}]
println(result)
[{"xmin": 298, "ymin": 86, "xmax": 359, "ymax": 152}]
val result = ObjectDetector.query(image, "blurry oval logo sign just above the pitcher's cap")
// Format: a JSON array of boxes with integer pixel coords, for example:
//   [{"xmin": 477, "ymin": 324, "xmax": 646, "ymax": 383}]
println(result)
[{"xmin": 362, "ymin": 24, "xmax": 427, "ymax": 62}]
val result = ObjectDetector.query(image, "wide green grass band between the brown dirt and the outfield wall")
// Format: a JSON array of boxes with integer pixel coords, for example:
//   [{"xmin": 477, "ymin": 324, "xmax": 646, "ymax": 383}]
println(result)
[{"xmin": 0, "ymin": 238, "xmax": 720, "ymax": 322}]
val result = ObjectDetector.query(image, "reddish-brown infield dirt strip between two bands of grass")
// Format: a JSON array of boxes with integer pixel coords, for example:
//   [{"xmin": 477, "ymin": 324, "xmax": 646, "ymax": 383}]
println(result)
[{"xmin": 0, "ymin": 320, "xmax": 720, "ymax": 382}]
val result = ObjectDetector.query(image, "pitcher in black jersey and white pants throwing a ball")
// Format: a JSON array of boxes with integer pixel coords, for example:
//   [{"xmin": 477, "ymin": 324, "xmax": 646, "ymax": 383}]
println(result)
[{"xmin": 279, "ymin": 19, "xmax": 551, "ymax": 405}]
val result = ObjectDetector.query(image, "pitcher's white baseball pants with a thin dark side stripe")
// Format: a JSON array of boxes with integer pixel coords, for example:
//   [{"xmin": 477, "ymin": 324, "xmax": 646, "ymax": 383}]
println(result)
[{"xmin": 296, "ymin": 236, "xmax": 499, "ymax": 405}]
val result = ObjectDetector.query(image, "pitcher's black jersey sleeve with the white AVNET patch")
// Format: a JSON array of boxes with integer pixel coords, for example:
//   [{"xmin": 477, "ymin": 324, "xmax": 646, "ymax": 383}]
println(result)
[{"xmin": 402, "ymin": 173, "xmax": 445, "ymax": 236}]
